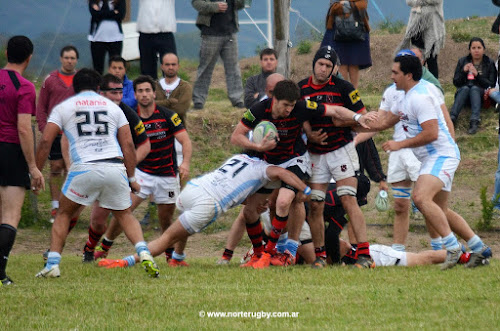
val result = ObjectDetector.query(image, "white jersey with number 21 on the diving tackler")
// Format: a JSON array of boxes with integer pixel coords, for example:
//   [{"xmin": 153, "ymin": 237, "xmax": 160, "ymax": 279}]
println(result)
[{"xmin": 191, "ymin": 154, "xmax": 270, "ymax": 212}]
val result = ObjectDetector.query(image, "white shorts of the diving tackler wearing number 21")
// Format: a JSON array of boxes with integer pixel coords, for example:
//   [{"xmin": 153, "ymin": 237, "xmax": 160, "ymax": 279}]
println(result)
[{"xmin": 176, "ymin": 182, "xmax": 222, "ymax": 234}]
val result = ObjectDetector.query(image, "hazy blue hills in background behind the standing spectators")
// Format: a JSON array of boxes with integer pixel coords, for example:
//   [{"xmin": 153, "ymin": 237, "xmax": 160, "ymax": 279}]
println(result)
[{"xmin": 0, "ymin": 0, "xmax": 499, "ymax": 77}]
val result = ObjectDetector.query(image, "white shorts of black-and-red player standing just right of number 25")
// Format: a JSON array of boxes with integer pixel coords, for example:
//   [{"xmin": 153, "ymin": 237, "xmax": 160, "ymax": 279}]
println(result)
[{"xmin": 135, "ymin": 169, "xmax": 181, "ymax": 205}]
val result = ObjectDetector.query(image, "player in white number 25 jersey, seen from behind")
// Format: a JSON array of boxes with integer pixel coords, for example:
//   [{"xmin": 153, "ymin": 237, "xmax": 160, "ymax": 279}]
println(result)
[{"xmin": 36, "ymin": 69, "xmax": 159, "ymax": 277}]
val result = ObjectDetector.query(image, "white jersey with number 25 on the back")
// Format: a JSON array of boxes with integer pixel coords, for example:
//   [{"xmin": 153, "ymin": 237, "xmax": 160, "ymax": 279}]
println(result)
[{"xmin": 48, "ymin": 91, "xmax": 128, "ymax": 164}]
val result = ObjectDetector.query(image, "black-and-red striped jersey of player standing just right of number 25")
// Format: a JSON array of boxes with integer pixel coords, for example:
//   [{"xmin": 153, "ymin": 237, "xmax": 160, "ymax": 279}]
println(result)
[{"xmin": 137, "ymin": 105, "xmax": 186, "ymax": 177}]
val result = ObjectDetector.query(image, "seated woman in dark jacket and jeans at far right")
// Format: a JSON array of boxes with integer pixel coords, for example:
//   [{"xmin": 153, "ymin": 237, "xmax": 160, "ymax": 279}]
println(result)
[{"xmin": 450, "ymin": 37, "xmax": 497, "ymax": 134}]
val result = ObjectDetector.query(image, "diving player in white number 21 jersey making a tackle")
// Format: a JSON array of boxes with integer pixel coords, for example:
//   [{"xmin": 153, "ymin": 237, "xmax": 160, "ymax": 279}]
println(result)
[{"xmin": 99, "ymin": 154, "xmax": 311, "ymax": 268}]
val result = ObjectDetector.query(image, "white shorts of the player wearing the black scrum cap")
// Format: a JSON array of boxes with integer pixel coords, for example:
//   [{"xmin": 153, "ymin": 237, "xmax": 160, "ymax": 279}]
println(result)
[{"xmin": 309, "ymin": 142, "xmax": 359, "ymax": 184}]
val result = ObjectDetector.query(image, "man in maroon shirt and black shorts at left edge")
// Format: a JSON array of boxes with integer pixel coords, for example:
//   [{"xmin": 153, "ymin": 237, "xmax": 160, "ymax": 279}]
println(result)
[{"xmin": 0, "ymin": 36, "xmax": 44, "ymax": 287}]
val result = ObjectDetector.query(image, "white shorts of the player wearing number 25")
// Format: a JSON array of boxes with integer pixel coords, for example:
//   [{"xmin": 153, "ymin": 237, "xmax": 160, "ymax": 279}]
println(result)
[{"xmin": 61, "ymin": 162, "xmax": 132, "ymax": 210}]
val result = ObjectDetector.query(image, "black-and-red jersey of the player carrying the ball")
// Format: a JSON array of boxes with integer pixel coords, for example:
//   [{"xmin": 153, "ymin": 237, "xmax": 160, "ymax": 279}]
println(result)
[{"xmin": 241, "ymin": 98, "xmax": 325, "ymax": 164}]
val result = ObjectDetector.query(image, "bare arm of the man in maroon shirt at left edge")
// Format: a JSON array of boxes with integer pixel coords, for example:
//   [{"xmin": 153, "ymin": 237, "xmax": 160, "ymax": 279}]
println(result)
[{"xmin": 17, "ymin": 114, "xmax": 45, "ymax": 191}]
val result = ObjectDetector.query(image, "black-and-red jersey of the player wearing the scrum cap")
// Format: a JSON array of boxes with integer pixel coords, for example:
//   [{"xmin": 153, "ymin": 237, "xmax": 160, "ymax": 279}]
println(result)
[{"xmin": 299, "ymin": 76, "xmax": 365, "ymax": 154}]
